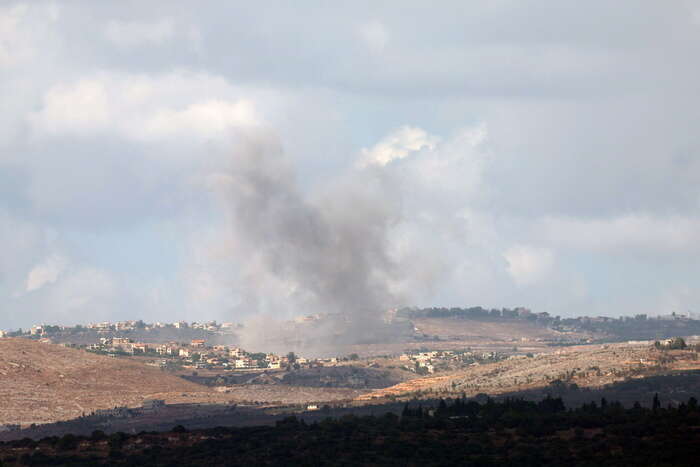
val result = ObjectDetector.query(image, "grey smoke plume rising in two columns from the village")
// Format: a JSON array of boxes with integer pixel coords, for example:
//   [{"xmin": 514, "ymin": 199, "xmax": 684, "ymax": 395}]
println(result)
[{"xmin": 211, "ymin": 134, "xmax": 412, "ymax": 350}]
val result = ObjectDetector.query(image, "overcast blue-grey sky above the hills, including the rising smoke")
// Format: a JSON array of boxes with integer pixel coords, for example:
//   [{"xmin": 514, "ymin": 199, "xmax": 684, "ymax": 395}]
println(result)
[{"xmin": 0, "ymin": 0, "xmax": 700, "ymax": 329}]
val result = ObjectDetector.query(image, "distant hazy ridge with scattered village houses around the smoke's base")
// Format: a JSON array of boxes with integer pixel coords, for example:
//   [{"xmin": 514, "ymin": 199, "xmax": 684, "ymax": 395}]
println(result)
[{"xmin": 0, "ymin": 307, "xmax": 700, "ymax": 375}]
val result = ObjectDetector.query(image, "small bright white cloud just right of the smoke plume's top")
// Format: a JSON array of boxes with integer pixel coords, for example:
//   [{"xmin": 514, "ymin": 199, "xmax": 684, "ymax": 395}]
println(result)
[{"xmin": 360, "ymin": 126, "xmax": 438, "ymax": 166}]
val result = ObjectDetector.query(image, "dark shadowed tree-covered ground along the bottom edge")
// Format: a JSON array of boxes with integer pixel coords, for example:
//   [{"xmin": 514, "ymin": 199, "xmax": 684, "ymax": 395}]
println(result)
[{"xmin": 0, "ymin": 396, "xmax": 700, "ymax": 466}]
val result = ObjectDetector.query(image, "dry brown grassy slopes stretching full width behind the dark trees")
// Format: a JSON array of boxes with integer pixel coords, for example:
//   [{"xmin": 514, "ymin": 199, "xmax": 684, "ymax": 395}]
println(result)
[{"xmin": 0, "ymin": 334, "xmax": 700, "ymax": 426}]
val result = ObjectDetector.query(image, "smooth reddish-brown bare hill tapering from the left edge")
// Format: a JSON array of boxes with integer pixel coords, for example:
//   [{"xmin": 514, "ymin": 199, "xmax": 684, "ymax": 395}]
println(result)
[{"xmin": 0, "ymin": 338, "xmax": 210, "ymax": 424}]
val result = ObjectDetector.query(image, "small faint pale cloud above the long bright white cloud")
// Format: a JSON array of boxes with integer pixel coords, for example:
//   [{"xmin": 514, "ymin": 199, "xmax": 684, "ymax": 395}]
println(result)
[{"xmin": 104, "ymin": 18, "xmax": 175, "ymax": 47}]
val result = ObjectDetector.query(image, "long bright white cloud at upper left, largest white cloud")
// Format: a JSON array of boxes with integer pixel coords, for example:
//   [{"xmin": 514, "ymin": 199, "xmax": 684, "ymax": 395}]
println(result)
[{"xmin": 29, "ymin": 72, "xmax": 261, "ymax": 141}]
